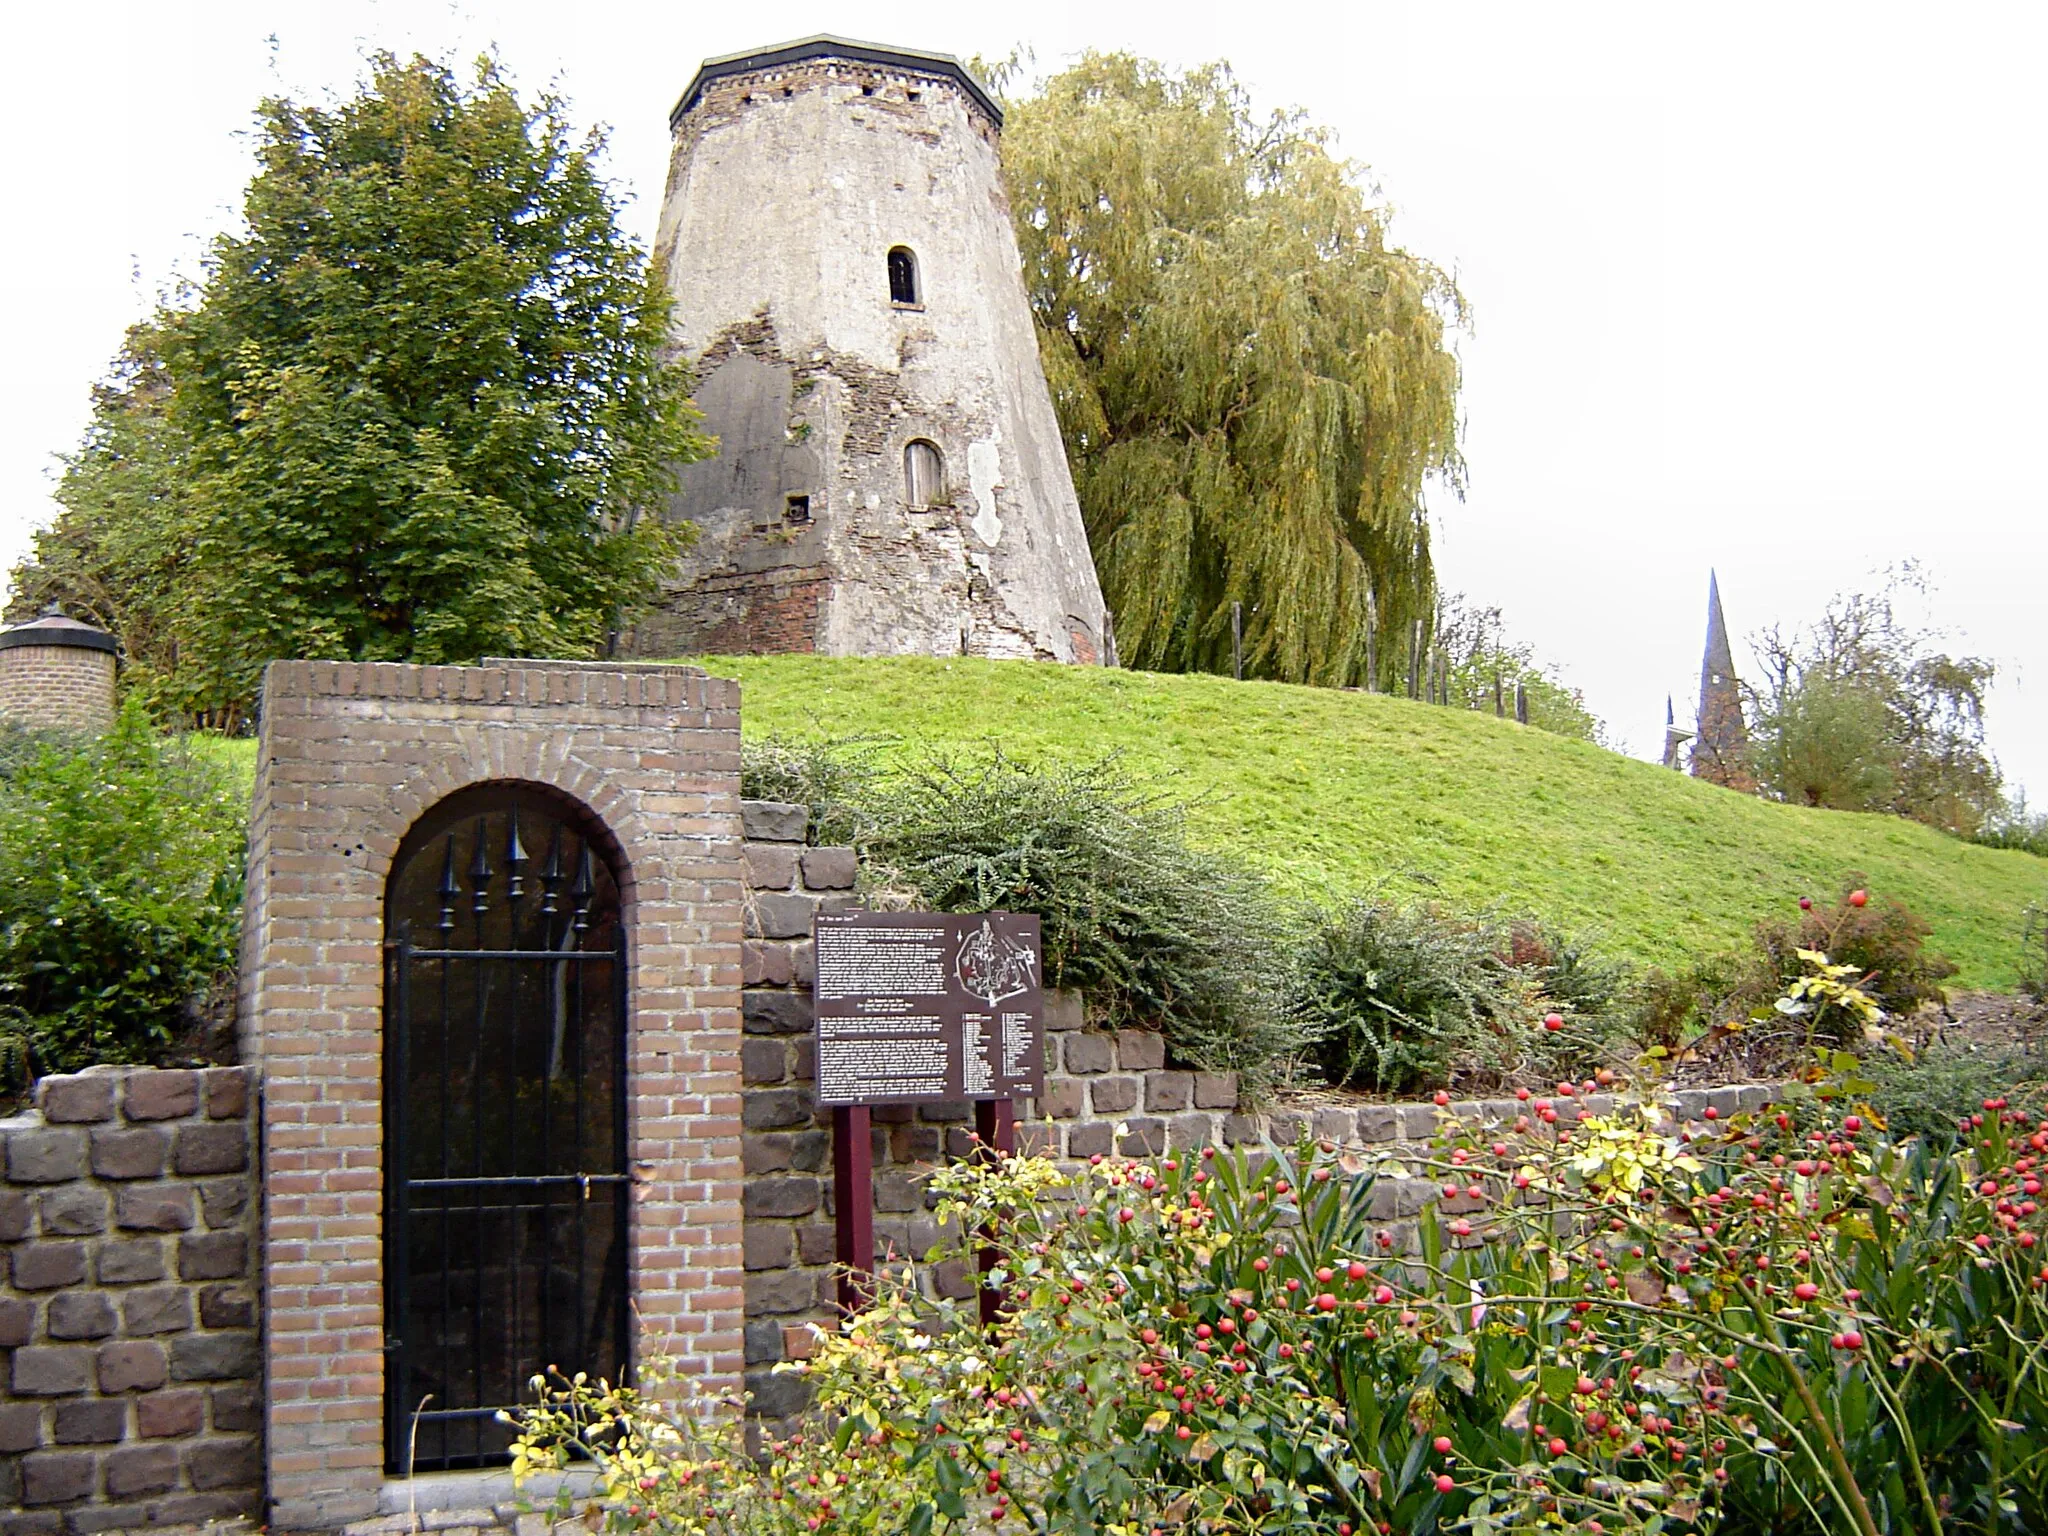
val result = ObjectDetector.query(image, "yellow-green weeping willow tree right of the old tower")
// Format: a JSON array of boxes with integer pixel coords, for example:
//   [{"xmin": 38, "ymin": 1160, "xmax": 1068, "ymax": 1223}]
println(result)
[{"xmin": 1004, "ymin": 53, "xmax": 1464, "ymax": 684}]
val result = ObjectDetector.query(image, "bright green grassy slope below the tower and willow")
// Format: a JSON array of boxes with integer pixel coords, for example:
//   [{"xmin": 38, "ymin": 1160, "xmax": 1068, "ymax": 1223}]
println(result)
[{"xmin": 694, "ymin": 655, "xmax": 2048, "ymax": 987}]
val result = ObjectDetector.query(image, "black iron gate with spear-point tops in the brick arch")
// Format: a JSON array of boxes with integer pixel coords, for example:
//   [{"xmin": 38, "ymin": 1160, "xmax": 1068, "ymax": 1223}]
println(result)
[{"xmin": 385, "ymin": 784, "xmax": 629, "ymax": 1473}]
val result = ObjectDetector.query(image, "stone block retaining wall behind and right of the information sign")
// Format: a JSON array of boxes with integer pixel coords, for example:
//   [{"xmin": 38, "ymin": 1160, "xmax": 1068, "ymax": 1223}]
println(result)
[{"xmin": 741, "ymin": 801, "xmax": 1772, "ymax": 1425}]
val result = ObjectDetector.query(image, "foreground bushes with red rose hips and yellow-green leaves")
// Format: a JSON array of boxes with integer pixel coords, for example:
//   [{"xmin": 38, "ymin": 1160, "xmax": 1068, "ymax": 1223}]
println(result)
[{"xmin": 516, "ymin": 1059, "xmax": 2048, "ymax": 1536}]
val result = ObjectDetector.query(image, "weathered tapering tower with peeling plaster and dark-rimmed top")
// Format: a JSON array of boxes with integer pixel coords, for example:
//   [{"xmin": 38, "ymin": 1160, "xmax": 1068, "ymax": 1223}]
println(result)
[{"xmin": 623, "ymin": 37, "xmax": 1114, "ymax": 664}]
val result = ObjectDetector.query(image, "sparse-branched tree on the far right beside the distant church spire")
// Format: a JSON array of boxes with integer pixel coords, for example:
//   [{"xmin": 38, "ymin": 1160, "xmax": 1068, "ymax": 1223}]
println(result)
[{"xmin": 1749, "ymin": 569, "xmax": 2003, "ymax": 836}]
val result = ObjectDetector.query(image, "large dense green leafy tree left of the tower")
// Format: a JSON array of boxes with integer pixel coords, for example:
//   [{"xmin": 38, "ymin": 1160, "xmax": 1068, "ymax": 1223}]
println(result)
[{"xmin": 16, "ymin": 55, "xmax": 707, "ymax": 723}]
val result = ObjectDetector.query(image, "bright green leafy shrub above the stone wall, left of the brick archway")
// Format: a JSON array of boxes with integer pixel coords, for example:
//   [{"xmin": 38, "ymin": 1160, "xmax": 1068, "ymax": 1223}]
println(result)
[{"xmin": 0, "ymin": 700, "xmax": 248, "ymax": 1071}]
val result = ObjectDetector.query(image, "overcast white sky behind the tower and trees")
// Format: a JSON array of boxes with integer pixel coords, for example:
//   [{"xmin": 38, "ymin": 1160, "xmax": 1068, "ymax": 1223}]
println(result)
[{"xmin": 0, "ymin": 0, "xmax": 2048, "ymax": 799}]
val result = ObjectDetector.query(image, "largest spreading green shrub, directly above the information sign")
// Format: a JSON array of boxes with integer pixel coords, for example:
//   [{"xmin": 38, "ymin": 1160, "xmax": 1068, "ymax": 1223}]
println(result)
[{"xmin": 866, "ymin": 752, "xmax": 1296, "ymax": 1092}]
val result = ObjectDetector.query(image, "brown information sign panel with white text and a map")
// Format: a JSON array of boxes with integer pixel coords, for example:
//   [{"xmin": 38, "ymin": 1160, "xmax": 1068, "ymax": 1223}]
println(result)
[{"xmin": 813, "ymin": 911, "xmax": 1044, "ymax": 1106}]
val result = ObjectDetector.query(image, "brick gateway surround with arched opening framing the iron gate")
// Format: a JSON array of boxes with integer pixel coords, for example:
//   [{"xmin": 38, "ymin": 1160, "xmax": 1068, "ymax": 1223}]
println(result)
[{"xmin": 242, "ymin": 662, "xmax": 741, "ymax": 1528}]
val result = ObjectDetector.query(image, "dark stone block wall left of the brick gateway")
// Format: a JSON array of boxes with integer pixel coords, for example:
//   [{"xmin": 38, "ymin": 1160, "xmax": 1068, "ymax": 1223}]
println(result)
[{"xmin": 0, "ymin": 1067, "xmax": 262, "ymax": 1536}]
